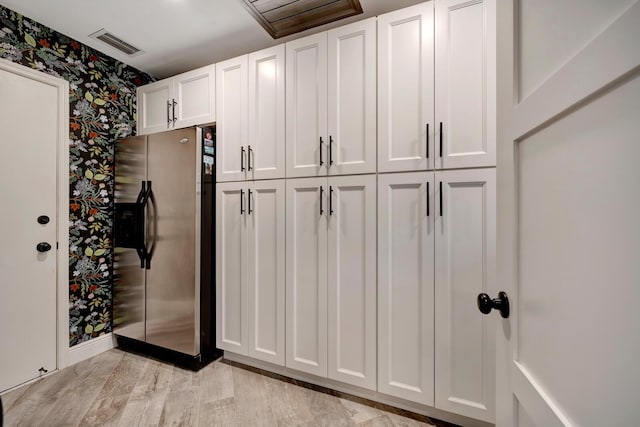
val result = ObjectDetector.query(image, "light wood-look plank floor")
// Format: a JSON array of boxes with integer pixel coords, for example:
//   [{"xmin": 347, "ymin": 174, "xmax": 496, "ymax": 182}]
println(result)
[{"xmin": 2, "ymin": 349, "xmax": 450, "ymax": 427}]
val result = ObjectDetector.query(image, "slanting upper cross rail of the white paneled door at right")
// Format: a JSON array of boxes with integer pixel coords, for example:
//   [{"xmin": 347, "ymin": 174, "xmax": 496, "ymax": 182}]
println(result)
[{"xmin": 511, "ymin": 2, "xmax": 640, "ymax": 140}]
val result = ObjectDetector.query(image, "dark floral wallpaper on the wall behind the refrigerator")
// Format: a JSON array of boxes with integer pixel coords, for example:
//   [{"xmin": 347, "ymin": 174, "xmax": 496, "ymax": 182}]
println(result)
[{"xmin": 0, "ymin": 6, "xmax": 153, "ymax": 346}]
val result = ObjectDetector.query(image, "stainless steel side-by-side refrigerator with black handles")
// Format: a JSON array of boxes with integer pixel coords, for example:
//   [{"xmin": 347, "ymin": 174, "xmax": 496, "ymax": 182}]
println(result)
[{"xmin": 113, "ymin": 128, "xmax": 221, "ymax": 370}]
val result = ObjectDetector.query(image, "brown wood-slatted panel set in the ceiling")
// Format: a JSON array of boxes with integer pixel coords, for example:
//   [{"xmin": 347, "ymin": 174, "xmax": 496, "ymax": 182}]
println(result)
[{"xmin": 243, "ymin": 0, "xmax": 362, "ymax": 39}]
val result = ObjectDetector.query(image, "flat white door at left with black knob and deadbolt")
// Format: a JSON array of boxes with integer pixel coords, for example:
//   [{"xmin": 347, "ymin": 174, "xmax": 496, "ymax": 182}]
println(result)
[{"xmin": 0, "ymin": 62, "xmax": 58, "ymax": 392}]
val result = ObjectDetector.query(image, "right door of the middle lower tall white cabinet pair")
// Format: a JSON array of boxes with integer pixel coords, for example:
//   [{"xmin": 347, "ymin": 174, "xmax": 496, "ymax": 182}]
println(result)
[{"xmin": 327, "ymin": 175, "xmax": 377, "ymax": 390}]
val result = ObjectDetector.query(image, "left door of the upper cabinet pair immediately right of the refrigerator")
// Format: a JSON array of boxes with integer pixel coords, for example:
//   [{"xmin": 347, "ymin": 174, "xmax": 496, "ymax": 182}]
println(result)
[{"xmin": 216, "ymin": 55, "xmax": 248, "ymax": 182}]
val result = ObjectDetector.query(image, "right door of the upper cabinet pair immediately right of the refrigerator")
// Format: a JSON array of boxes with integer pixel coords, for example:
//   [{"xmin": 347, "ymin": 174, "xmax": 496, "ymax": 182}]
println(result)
[{"xmin": 247, "ymin": 45, "xmax": 285, "ymax": 179}]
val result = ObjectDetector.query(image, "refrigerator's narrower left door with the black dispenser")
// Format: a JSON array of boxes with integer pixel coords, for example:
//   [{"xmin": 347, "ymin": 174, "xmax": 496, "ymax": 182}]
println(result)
[{"xmin": 113, "ymin": 136, "xmax": 147, "ymax": 341}]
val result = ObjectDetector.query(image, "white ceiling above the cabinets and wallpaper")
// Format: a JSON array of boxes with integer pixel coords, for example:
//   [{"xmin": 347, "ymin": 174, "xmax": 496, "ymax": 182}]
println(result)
[{"xmin": 0, "ymin": 0, "xmax": 422, "ymax": 78}]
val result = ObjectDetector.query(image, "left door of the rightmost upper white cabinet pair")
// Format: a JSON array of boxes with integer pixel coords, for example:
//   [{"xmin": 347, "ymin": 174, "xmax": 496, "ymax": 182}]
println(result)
[{"xmin": 378, "ymin": 2, "xmax": 435, "ymax": 172}]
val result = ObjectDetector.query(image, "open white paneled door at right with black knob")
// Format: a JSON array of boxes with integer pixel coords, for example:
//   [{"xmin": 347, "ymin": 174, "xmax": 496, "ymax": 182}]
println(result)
[{"xmin": 498, "ymin": 0, "xmax": 640, "ymax": 427}]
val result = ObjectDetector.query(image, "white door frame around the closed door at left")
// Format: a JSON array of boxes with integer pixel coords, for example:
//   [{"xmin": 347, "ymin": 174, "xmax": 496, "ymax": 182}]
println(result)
[{"xmin": 0, "ymin": 58, "xmax": 69, "ymax": 371}]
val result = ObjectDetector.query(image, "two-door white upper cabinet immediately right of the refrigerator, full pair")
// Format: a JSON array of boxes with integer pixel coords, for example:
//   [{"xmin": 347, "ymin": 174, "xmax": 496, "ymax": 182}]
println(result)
[{"xmin": 216, "ymin": 45, "xmax": 285, "ymax": 182}]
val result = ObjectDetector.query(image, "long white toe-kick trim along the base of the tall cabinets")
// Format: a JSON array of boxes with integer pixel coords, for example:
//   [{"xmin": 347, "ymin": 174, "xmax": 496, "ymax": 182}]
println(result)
[{"xmin": 224, "ymin": 351, "xmax": 493, "ymax": 427}]
